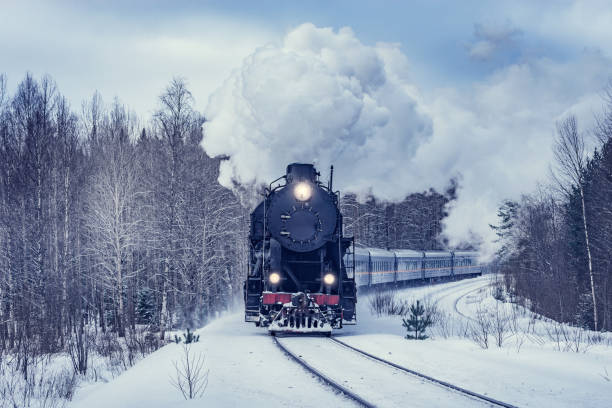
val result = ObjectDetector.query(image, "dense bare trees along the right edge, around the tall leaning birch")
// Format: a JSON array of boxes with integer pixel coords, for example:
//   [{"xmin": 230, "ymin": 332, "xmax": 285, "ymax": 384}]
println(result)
[{"xmin": 492, "ymin": 85, "xmax": 612, "ymax": 331}]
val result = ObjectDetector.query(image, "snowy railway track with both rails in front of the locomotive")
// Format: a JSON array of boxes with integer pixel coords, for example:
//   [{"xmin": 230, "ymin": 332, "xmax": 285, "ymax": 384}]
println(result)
[{"xmin": 272, "ymin": 337, "xmax": 516, "ymax": 408}]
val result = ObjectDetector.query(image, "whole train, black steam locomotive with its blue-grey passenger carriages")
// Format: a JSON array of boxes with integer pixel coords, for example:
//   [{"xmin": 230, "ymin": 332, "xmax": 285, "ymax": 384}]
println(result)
[{"xmin": 244, "ymin": 163, "xmax": 484, "ymax": 335}]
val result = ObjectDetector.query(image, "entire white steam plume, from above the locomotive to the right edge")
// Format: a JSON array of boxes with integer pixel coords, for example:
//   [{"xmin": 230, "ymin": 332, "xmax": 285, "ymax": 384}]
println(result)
[{"xmin": 203, "ymin": 24, "xmax": 611, "ymax": 253}]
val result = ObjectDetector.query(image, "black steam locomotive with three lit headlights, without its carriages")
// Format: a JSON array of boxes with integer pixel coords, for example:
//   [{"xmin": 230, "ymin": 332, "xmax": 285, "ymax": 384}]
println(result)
[{"xmin": 244, "ymin": 163, "xmax": 357, "ymax": 334}]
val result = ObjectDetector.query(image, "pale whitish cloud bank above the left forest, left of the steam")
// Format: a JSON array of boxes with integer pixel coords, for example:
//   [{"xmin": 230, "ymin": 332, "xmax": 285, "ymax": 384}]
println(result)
[{"xmin": 0, "ymin": 0, "xmax": 279, "ymax": 117}]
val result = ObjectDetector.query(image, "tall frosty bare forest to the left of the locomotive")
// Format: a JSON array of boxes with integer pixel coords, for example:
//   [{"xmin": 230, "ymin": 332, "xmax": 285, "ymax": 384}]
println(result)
[{"xmin": 0, "ymin": 74, "xmax": 248, "ymax": 353}]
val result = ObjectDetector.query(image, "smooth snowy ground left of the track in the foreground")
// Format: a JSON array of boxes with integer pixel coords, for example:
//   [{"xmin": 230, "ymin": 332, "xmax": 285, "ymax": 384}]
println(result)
[{"xmin": 70, "ymin": 313, "xmax": 354, "ymax": 408}]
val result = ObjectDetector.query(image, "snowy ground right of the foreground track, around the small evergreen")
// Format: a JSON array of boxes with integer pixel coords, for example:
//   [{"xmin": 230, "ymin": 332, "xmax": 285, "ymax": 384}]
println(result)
[{"xmin": 338, "ymin": 276, "xmax": 612, "ymax": 407}]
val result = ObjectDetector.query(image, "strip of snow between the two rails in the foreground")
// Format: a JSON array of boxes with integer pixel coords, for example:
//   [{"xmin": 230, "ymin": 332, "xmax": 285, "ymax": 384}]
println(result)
[{"xmin": 278, "ymin": 336, "xmax": 489, "ymax": 407}]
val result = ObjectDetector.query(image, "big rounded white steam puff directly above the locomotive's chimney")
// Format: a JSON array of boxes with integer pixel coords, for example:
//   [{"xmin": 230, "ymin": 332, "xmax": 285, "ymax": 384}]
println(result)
[{"xmin": 203, "ymin": 24, "xmax": 432, "ymax": 200}]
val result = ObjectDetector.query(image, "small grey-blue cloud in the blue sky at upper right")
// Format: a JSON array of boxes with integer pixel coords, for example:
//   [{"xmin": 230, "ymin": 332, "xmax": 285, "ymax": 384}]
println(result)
[{"xmin": 468, "ymin": 22, "xmax": 521, "ymax": 60}]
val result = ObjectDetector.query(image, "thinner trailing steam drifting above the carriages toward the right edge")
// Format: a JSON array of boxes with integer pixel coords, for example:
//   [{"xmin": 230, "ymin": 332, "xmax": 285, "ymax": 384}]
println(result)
[{"xmin": 430, "ymin": 51, "xmax": 612, "ymax": 253}]
